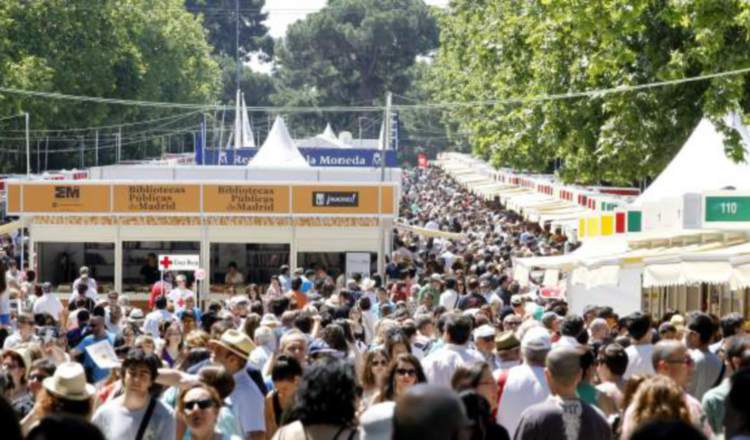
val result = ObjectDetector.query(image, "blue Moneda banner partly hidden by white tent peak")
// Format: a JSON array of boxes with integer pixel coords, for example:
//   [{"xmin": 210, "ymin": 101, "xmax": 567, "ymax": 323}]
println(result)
[{"xmin": 195, "ymin": 147, "xmax": 398, "ymax": 168}]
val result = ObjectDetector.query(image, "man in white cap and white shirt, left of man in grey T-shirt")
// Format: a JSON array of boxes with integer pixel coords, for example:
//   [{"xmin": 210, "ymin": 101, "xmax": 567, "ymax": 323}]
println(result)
[{"xmin": 497, "ymin": 326, "xmax": 552, "ymax": 437}]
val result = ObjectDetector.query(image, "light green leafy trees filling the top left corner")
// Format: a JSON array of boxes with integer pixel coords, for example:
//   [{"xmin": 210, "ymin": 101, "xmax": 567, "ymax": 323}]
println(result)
[{"xmin": 0, "ymin": 0, "xmax": 220, "ymax": 172}]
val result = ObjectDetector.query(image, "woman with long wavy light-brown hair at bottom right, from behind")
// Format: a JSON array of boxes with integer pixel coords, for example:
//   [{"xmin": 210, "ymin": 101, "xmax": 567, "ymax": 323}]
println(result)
[{"xmin": 621, "ymin": 375, "xmax": 691, "ymax": 439}]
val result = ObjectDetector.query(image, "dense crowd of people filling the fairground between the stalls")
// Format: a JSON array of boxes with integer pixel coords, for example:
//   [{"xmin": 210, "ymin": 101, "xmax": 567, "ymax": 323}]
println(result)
[{"xmin": 0, "ymin": 167, "xmax": 750, "ymax": 440}]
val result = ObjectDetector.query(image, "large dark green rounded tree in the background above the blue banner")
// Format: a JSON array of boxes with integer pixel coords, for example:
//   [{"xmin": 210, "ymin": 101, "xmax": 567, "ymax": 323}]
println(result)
[{"xmin": 273, "ymin": 0, "xmax": 438, "ymax": 134}]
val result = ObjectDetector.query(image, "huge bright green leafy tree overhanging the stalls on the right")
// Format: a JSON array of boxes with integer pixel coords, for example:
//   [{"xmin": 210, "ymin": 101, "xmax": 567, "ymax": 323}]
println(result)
[{"xmin": 433, "ymin": 0, "xmax": 750, "ymax": 184}]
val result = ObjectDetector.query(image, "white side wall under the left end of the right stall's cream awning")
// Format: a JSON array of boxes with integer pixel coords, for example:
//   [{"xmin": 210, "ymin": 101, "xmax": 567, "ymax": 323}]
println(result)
[{"xmin": 566, "ymin": 267, "xmax": 642, "ymax": 316}]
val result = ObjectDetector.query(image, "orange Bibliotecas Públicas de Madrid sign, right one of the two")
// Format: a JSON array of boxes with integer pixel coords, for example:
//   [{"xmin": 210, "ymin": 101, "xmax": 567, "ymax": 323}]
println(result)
[{"xmin": 203, "ymin": 185, "xmax": 289, "ymax": 214}]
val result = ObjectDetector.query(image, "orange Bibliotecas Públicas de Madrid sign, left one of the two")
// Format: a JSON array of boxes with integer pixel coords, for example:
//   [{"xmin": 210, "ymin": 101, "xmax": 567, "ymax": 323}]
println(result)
[{"xmin": 114, "ymin": 183, "xmax": 201, "ymax": 213}]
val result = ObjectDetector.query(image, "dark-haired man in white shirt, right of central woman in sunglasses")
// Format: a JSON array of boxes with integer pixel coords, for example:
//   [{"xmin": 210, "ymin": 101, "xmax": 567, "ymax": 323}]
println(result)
[{"xmin": 422, "ymin": 314, "xmax": 484, "ymax": 387}]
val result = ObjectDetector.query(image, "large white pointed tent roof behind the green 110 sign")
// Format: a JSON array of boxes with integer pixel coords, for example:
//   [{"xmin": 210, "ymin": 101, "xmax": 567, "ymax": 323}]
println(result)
[{"xmin": 634, "ymin": 118, "xmax": 750, "ymax": 206}]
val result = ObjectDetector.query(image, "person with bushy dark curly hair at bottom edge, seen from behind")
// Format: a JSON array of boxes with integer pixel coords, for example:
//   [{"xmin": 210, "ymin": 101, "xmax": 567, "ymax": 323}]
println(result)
[{"xmin": 273, "ymin": 359, "xmax": 359, "ymax": 440}]
